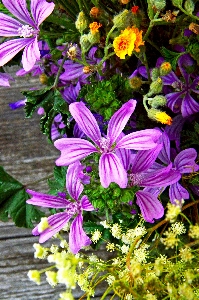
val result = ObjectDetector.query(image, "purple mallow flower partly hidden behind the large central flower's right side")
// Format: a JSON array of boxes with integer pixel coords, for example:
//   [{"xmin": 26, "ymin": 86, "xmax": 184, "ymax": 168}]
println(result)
[{"xmin": 118, "ymin": 144, "xmax": 180, "ymax": 223}]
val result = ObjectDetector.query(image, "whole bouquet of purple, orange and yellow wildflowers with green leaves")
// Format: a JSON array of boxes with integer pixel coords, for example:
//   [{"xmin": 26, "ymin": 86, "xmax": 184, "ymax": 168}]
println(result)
[{"xmin": 0, "ymin": 0, "xmax": 199, "ymax": 300}]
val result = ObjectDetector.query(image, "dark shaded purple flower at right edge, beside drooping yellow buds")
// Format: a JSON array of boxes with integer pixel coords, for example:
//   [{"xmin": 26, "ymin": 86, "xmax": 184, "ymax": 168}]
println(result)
[{"xmin": 162, "ymin": 54, "xmax": 199, "ymax": 117}]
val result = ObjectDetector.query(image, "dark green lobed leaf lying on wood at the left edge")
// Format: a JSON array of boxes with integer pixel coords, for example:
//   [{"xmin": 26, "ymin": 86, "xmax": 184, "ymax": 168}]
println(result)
[{"xmin": 0, "ymin": 167, "xmax": 44, "ymax": 228}]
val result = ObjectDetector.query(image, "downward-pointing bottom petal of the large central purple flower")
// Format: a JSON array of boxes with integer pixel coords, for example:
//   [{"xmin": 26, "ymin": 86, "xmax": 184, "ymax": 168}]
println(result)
[{"xmin": 99, "ymin": 153, "xmax": 128, "ymax": 188}]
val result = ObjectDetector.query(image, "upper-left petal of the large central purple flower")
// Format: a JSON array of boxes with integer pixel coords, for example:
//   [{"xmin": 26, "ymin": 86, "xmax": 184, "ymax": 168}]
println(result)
[{"xmin": 69, "ymin": 102, "xmax": 101, "ymax": 146}]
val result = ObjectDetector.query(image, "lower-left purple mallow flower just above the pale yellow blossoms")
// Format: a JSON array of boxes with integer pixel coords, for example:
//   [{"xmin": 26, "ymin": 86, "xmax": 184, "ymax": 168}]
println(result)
[{"xmin": 26, "ymin": 161, "xmax": 94, "ymax": 254}]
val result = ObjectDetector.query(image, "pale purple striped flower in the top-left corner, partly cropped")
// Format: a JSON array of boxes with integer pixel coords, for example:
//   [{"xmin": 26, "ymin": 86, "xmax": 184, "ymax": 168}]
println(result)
[{"xmin": 0, "ymin": 0, "xmax": 55, "ymax": 71}]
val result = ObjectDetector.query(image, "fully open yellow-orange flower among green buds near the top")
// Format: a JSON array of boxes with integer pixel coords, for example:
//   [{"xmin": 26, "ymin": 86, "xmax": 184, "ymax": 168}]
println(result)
[{"xmin": 113, "ymin": 26, "xmax": 144, "ymax": 59}]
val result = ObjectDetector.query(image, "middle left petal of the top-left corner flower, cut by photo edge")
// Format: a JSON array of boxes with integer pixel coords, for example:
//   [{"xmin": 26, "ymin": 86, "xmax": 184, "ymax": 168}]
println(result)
[{"xmin": 0, "ymin": 13, "xmax": 23, "ymax": 37}]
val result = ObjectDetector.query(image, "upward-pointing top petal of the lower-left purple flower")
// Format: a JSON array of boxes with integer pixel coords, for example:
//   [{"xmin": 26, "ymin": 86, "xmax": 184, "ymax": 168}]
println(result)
[{"xmin": 66, "ymin": 161, "xmax": 84, "ymax": 200}]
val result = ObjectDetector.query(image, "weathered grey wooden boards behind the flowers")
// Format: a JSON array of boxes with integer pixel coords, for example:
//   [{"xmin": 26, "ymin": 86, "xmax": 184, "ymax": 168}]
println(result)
[{"xmin": 0, "ymin": 67, "xmax": 109, "ymax": 300}]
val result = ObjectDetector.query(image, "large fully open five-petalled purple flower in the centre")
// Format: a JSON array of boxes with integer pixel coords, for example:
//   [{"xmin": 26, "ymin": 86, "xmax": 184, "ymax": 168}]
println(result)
[{"xmin": 54, "ymin": 100, "xmax": 161, "ymax": 188}]
